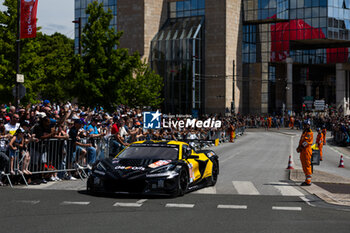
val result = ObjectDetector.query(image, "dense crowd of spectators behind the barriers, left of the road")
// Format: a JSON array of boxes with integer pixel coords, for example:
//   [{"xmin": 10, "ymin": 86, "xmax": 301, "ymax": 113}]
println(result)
[{"xmin": 0, "ymin": 100, "xmax": 244, "ymax": 184}]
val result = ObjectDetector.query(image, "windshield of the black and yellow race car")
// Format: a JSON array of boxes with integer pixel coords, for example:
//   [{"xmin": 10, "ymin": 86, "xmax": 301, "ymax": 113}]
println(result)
[{"xmin": 118, "ymin": 144, "xmax": 179, "ymax": 160}]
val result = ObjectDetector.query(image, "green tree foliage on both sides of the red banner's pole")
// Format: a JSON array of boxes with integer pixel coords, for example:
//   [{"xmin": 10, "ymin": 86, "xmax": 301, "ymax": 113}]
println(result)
[{"xmin": 0, "ymin": 0, "xmax": 74, "ymax": 102}]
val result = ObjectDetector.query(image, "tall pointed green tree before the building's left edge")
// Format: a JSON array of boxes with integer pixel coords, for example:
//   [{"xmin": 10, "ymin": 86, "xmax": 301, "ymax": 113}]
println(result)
[{"xmin": 73, "ymin": 1, "xmax": 137, "ymax": 109}]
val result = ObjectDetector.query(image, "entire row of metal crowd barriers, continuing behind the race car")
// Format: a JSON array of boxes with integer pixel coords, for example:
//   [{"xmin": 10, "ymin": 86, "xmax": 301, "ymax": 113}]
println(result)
[{"xmin": 0, "ymin": 127, "xmax": 244, "ymax": 187}]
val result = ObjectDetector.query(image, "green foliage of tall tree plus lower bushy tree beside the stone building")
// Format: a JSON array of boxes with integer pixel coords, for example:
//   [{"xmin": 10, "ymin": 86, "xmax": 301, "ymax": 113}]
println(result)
[{"xmin": 73, "ymin": 1, "xmax": 162, "ymax": 110}]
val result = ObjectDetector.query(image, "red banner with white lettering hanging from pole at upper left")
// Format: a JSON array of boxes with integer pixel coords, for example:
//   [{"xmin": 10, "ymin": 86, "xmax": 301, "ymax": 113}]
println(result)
[{"xmin": 21, "ymin": 0, "xmax": 38, "ymax": 39}]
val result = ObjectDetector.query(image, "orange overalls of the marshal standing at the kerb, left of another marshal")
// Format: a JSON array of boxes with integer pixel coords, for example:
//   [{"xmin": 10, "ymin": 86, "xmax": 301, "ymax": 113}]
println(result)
[{"xmin": 299, "ymin": 129, "xmax": 314, "ymax": 184}]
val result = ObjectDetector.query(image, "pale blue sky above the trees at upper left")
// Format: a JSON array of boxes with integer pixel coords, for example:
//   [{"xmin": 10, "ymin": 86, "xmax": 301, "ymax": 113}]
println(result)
[{"xmin": 0, "ymin": 0, "xmax": 74, "ymax": 39}]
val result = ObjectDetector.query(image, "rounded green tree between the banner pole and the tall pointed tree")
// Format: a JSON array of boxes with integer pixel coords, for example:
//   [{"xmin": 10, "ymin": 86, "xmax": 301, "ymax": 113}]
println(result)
[{"xmin": 21, "ymin": 33, "xmax": 74, "ymax": 102}]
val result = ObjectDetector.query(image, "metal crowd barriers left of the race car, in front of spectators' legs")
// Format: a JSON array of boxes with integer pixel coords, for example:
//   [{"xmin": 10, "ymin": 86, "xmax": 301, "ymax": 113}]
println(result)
[{"xmin": 0, "ymin": 138, "xmax": 109, "ymax": 187}]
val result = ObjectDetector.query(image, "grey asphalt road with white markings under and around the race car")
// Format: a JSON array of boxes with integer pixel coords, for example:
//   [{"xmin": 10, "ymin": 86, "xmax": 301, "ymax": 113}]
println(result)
[{"xmin": 0, "ymin": 131, "xmax": 350, "ymax": 233}]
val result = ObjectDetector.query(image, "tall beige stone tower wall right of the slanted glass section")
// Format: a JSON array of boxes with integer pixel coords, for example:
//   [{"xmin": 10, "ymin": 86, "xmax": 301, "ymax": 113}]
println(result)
[{"xmin": 205, "ymin": 0, "xmax": 242, "ymax": 113}]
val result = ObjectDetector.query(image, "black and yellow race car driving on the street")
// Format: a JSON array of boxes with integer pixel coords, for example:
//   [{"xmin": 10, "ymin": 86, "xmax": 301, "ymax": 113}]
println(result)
[{"xmin": 87, "ymin": 141, "xmax": 219, "ymax": 196}]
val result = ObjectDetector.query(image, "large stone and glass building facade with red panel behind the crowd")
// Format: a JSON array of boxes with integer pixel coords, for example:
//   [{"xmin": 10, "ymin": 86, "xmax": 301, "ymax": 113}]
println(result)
[{"xmin": 75, "ymin": 0, "xmax": 350, "ymax": 114}]
